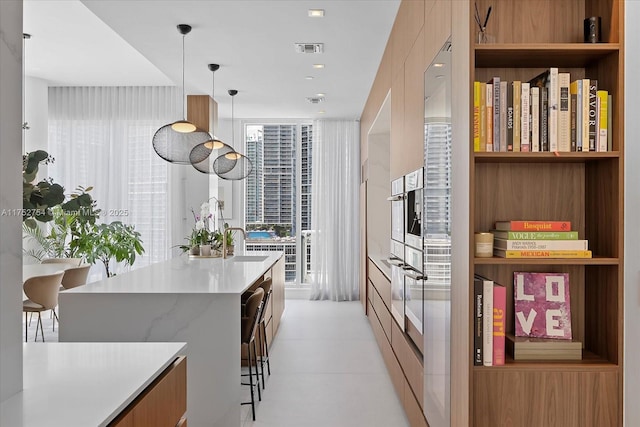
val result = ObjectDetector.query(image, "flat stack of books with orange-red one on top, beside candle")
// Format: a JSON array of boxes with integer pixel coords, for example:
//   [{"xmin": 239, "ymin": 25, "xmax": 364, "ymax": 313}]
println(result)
[{"xmin": 492, "ymin": 221, "xmax": 592, "ymax": 258}]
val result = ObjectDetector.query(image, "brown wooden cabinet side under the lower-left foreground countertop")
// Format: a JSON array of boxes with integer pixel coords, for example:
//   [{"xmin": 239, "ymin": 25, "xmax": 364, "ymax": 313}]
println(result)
[{"xmin": 109, "ymin": 356, "xmax": 187, "ymax": 427}]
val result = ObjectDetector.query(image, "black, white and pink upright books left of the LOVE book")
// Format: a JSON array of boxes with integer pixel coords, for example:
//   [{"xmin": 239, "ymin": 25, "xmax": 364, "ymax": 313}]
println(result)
[{"xmin": 473, "ymin": 274, "xmax": 507, "ymax": 366}]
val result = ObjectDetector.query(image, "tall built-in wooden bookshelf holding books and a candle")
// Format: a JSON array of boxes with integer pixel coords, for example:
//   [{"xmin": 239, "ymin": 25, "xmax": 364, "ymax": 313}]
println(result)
[{"xmin": 469, "ymin": 0, "xmax": 624, "ymax": 427}]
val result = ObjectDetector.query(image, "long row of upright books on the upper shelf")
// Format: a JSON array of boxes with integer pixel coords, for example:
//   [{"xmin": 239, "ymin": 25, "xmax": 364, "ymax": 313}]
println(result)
[{"xmin": 473, "ymin": 67, "xmax": 613, "ymax": 152}]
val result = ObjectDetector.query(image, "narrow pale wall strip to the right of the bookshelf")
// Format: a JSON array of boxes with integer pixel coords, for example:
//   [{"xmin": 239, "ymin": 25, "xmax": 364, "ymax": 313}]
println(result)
[{"xmin": 624, "ymin": 1, "xmax": 640, "ymax": 427}]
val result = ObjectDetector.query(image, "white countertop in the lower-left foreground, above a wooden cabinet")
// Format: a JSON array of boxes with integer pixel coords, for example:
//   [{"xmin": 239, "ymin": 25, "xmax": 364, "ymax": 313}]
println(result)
[{"xmin": 0, "ymin": 343, "xmax": 186, "ymax": 427}]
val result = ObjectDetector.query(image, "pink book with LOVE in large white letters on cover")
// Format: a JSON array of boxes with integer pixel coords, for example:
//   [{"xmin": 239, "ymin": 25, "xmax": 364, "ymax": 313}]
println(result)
[{"xmin": 513, "ymin": 271, "xmax": 572, "ymax": 340}]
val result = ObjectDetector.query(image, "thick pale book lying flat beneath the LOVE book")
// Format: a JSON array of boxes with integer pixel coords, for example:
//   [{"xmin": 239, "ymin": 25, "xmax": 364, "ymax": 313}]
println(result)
[{"xmin": 506, "ymin": 334, "xmax": 582, "ymax": 360}]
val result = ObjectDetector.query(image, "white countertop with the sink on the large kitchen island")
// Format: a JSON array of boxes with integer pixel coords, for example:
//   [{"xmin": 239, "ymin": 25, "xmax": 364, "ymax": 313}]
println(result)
[{"xmin": 61, "ymin": 252, "xmax": 283, "ymax": 296}]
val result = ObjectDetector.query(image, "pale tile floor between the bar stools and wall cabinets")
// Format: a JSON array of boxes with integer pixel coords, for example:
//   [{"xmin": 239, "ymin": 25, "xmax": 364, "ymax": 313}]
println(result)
[{"xmin": 242, "ymin": 299, "xmax": 409, "ymax": 427}]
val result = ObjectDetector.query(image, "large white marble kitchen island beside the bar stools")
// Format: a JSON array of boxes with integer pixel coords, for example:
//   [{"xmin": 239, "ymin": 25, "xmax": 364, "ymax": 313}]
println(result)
[{"xmin": 59, "ymin": 252, "xmax": 284, "ymax": 427}]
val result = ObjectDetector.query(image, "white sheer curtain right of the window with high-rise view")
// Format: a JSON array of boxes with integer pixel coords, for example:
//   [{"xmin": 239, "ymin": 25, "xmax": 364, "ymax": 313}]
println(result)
[{"xmin": 311, "ymin": 120, "xmax": 360, "ymax": 301}]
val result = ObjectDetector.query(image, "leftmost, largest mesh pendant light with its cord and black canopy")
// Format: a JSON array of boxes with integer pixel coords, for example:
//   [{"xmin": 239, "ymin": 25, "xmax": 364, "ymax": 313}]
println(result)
[{"xmin": 153, "ymin": 24, "xmax": 209, "ymax": 164}]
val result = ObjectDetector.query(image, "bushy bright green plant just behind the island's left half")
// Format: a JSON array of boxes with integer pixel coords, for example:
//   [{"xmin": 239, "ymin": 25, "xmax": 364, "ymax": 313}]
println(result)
[{"xmin": 71, "ymin": 221, "xmax": 144, "ymax": 277}]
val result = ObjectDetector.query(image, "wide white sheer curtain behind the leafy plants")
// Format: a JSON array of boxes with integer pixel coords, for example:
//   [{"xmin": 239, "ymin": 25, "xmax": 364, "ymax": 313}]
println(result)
[{"xmin": 48, "ymin": 87, "xmax": 182, "ymax": 278}]
